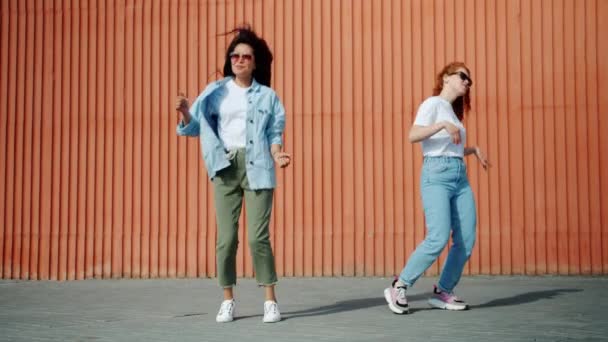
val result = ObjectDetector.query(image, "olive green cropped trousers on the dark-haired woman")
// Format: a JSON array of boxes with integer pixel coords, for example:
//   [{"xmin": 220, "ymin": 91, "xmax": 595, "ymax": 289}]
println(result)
[{"xmin": 213, "ymin": 149, "xmax": 277, "ymax": 288}]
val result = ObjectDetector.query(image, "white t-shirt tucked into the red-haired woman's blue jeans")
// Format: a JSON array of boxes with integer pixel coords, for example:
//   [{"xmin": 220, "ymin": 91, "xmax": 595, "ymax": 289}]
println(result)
[{"xmin": 414, "ymin": 96, "xmax": 466, "ymax": 157}]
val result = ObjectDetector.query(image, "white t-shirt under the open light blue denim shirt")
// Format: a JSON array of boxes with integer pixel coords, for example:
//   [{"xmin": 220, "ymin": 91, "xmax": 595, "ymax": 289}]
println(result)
[{"xmin": 218, "ymin": 80, "xmax": 249, "ymax": 149}]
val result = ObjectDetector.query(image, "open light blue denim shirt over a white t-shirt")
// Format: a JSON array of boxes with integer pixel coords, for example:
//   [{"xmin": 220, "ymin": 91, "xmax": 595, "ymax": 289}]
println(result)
[{"xmin": 177, "ymin": 77, "xmax": 285, "ymax": 190}]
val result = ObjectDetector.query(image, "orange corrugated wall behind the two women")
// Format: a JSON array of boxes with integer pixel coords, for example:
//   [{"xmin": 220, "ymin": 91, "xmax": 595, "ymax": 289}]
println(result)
[{"xmin": 0, "ymin": 0, "xmax": 608, "ymax": 280}]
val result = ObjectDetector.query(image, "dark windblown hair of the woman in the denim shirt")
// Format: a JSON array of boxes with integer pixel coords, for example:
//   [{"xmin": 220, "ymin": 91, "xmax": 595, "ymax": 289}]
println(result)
[{"xmin": 224, "ymin": 24, "xmax": 272, "ymax": 87}]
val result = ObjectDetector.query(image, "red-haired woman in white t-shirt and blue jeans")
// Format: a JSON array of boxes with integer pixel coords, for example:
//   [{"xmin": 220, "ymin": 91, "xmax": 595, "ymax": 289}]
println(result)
[{"xmin": 384, "ymin": 62, "xmax": 489, "ymax": 314}]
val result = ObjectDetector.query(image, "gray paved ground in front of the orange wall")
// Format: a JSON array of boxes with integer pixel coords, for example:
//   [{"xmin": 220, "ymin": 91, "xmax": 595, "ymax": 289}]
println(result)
[{"xmin": 0, "ymin": 277, "xmax": 608, "ymax": 342}]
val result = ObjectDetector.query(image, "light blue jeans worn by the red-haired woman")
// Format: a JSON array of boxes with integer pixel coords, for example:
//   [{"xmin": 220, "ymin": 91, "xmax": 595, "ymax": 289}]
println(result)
[{"xmin": 399, "ymin": 157, "xmax": 477, "ymax": 292}]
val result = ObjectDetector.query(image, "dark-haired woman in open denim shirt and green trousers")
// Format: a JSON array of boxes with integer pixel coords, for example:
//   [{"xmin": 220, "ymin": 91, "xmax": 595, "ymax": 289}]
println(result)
[{"xmin": 176, "ymin": 27, "xmax": 291, "ymax": 323}]
